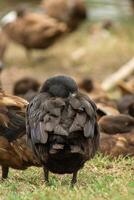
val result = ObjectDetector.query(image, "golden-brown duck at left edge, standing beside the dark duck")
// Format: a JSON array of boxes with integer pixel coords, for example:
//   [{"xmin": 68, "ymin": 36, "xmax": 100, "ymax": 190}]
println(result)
[{"xmin": 0, "ymin": 90, "xmax": 39, "ymax": 179}]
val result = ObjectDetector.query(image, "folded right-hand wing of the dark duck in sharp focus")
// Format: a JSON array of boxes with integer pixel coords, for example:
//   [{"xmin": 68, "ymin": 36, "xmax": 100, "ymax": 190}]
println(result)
[{"xmin": 69, "ymin": 93, "xmax": 96, "ymax": 138}]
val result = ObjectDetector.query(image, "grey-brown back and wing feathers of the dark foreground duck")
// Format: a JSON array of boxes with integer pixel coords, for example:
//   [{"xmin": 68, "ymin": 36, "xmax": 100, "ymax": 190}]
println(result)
[{"xmin": 27, "ymin": 94, "xmax": 99, "ymax": 150}]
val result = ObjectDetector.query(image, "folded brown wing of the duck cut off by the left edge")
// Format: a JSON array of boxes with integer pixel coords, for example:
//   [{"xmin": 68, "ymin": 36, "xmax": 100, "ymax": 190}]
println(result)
[{"xmin": 0, "ymin": 92, "xmax": 28, "ymax": 141}]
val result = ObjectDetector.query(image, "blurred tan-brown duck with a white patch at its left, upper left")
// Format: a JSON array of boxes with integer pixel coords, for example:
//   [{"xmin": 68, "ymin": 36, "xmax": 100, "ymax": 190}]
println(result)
[{"xmin": 1, "ymin": 8, "xmax": 67, "ymax": 56}]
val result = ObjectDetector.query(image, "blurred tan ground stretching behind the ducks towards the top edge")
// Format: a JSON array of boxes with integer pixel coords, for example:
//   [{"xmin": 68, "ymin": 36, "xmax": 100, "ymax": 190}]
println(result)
[{"xmin": 0, "ymin": 0, "xmax": 134, "ymax": 97}]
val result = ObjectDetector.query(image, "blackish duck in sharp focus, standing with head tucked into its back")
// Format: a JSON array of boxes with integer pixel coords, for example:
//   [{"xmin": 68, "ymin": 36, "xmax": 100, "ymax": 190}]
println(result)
[{"xmin": 27, "ymin": 76, "xmax": 99, "ymax": 185}]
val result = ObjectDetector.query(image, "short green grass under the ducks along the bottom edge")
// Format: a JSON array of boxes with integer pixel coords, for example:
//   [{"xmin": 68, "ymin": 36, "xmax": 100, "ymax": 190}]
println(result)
[{"xmin": 0, "ymin": 155, "xmax": 134, "ymax": 200}]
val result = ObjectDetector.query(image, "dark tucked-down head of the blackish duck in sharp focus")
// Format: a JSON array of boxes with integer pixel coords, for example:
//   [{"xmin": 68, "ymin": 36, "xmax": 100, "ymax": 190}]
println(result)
[{"xmin": 40, "ymin": 76, "xmax": 78, "ymax": 98}]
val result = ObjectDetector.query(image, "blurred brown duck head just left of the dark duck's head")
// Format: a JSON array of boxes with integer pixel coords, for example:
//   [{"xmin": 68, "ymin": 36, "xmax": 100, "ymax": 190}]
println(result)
[{"xmin": 13, "ymin": 77, "xmax": 40, "ymax": 102}]
